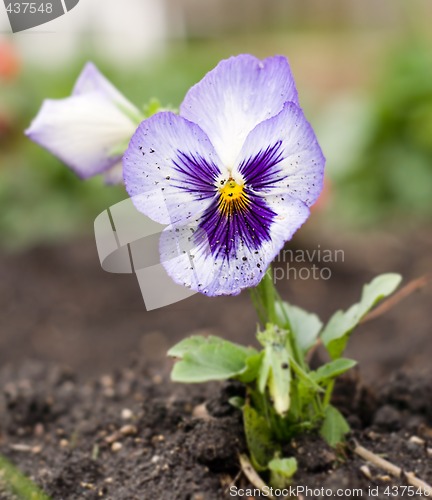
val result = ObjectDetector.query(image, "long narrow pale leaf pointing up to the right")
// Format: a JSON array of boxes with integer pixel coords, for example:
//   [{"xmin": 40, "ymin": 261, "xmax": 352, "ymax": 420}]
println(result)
[{"xmin": 321, "ymin": 273, "xmax": 401, "ymax": 359}]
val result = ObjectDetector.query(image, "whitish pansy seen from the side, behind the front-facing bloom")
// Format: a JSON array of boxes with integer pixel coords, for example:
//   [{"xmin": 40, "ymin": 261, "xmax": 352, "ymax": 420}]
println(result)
[{"xmin": 26, "ymin": 63, "xmax": 142, "ymax": 183}]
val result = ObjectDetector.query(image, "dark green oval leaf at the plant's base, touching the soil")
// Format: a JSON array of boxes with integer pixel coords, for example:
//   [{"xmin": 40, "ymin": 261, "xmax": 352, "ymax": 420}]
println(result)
[{"xmin": 243, "ymin": 405, "xmax": 275, "ymax": 471}]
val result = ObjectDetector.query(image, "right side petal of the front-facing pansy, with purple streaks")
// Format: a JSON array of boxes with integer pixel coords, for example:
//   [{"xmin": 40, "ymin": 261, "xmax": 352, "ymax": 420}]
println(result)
[{"xmin": 234, "ymin": 103, "xmax": 325, "ymax": 207}]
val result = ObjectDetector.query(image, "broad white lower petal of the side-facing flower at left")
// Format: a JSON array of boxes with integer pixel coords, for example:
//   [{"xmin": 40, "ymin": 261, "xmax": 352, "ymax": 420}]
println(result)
[{"xmin": 26, "ymin": 91, "xmax": 136, "ymax": 178}]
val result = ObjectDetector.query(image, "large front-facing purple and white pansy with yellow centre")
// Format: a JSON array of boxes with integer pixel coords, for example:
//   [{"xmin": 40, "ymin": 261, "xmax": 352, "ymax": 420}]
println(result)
[{"xmin": 123, "ymin": 55, "xmax": 325, "ymax": 296}]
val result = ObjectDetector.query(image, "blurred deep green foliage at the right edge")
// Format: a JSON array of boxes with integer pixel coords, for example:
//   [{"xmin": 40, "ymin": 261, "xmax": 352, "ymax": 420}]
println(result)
[{"xmin": 333, "ymin": 40, "xmax": 432, "ymax": 224}]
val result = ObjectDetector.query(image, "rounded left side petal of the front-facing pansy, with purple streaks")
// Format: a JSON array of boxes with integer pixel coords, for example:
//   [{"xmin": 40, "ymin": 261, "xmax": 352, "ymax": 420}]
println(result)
[{"xmin": 123, "ymin": 112, "xmax": 223, "ymax": 224}]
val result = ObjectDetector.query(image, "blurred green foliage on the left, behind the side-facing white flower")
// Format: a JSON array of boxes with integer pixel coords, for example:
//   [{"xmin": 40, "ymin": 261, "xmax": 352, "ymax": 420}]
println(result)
[{"xmin": 0, "ymin": 43, "xmax": 230, "ymax": 250}]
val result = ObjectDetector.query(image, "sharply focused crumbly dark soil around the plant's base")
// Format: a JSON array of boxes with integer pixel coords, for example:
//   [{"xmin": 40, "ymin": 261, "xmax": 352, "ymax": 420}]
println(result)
[{"xmin": 0, "ymin": 364, "xmax": 432, "ymax": 500}]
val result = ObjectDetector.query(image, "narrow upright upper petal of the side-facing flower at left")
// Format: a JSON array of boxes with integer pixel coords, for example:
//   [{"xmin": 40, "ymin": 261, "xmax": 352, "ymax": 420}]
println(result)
[{"xmin": 72, "ymin": 62, "xmax": 141, "ymax": 124}]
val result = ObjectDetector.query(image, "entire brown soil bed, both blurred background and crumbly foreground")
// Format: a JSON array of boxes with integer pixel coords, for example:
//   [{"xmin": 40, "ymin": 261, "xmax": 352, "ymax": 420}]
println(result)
[{"xmin": 0, "ymin": 228, "xmax": 432, "ymax": 500}]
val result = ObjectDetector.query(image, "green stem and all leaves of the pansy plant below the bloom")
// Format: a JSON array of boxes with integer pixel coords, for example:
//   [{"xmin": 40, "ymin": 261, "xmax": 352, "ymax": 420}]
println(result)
[{"xmin": 168, "ymin": 271, "xmax": 401, "ymax": 458}]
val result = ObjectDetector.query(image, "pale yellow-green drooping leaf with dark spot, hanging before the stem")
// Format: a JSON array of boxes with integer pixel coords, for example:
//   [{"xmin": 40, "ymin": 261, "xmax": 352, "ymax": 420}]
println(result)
[{"xmin": 258, "ymin": 325, "xmax": 291, "ymax": 415}]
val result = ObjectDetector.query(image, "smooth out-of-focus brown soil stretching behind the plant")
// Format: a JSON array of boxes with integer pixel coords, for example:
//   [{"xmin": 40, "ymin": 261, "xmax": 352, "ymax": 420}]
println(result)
[{"xmin": 0, "ymin": 225, "xmax": 432, "ymax": 382}]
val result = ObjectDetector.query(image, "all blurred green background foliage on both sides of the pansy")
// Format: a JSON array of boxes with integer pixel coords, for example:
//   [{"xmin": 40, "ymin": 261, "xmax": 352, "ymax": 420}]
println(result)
[{"xmin": 0, "ymin": 34, "xmax": 432, "ymax": 250}]
